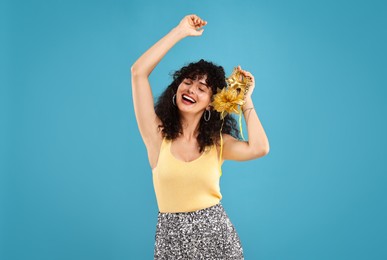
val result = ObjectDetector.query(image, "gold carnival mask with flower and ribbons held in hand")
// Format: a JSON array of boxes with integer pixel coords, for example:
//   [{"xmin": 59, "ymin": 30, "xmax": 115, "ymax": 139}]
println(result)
[{"xmin": 211, "ymin": 67, "xmax": 251, "ymax": 175}]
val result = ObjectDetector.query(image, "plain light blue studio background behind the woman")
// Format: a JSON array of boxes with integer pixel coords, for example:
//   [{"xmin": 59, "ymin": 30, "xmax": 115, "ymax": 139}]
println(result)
[{"xmin": 0, "ymin": 0, "xmax": 387, "ymax": 260}]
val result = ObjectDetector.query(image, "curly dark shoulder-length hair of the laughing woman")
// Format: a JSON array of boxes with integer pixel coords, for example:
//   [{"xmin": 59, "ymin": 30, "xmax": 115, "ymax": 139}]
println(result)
[{"xmin": 155, "ymin": 59, "xmax": 241, "ymax": 153}]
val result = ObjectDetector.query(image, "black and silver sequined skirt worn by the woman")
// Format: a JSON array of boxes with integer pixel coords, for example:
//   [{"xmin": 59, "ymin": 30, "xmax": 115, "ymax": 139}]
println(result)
[{"xmin": 154, "ymin": 202, "xmax": 244, "ymax": 260}]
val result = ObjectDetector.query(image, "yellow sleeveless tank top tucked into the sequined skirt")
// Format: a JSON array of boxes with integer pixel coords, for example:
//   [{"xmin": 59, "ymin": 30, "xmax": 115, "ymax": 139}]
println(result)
[{"xmin": 152, "ymin": 137, "xmax": 222, "ymax": 213}]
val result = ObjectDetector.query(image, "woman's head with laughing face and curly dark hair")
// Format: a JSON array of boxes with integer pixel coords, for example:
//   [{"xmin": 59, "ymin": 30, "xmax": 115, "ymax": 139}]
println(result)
[{"xmin": 155, "ymin": 59, "xmax": 240, "ymax": 153}]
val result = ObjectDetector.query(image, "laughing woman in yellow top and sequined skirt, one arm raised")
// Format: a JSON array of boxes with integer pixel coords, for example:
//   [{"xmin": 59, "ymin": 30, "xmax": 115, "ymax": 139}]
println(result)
[{"xmin": 131, "ymin": 15, "xmax": 269, "ymax": 259}]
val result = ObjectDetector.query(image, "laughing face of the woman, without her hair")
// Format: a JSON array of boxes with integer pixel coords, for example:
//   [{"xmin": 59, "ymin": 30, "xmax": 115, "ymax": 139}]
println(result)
[{"xmin": 176, "ymin": 75, "xmax": 212, "ymax": 113}]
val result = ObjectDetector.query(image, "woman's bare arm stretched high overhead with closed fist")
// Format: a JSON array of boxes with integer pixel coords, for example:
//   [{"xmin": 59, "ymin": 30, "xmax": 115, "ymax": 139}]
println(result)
[{"xmin": 131, "ymin": 15, "xmax": 207, "ymax": 146}]
